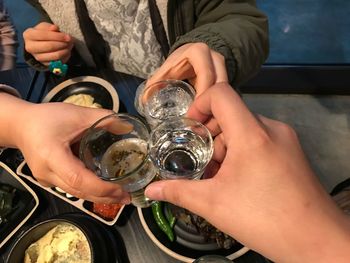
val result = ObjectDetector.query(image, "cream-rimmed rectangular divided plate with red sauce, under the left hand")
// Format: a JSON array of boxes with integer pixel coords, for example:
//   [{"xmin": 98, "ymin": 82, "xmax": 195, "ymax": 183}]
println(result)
[{"xmin": 16, "ymin": 161, "xmax": 124, "ymax": 226}]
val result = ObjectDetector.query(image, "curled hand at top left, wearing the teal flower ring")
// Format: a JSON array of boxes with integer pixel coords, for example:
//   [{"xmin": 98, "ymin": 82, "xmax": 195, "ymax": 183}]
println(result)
[{"xmin": 23, "ymin": 22, "xmax": 74, "ymax": 66}]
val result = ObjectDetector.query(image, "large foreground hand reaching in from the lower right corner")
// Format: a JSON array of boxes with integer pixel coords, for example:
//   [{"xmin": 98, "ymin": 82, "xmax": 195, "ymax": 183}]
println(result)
[{"xmin": 145, "ymin": 83, "xmax": 350, "ymax": 262}]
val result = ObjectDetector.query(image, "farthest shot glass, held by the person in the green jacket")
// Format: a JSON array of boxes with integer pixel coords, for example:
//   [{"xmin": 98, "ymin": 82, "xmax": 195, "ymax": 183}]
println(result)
[{"xmin": 134, "ymin": 79, "xmax": 196, "ymax": 128}]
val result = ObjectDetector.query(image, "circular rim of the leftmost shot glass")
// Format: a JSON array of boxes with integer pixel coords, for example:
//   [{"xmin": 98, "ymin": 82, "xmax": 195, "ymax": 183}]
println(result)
[{"xmin": 79, "ymin": 112, "xmax": 151, "ymax": 182}]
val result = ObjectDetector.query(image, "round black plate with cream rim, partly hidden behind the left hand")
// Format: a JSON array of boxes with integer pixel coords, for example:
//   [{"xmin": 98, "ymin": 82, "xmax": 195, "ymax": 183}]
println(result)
[{"xmin": 42, "ymin": 76, "xmax": 119, "ymax": 112}]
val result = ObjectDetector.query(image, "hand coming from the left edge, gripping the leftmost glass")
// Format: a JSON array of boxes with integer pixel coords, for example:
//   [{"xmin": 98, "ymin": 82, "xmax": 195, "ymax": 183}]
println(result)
[{"xmin": 12, "ymin": 99, "xmax": 130, "ymax": 203}]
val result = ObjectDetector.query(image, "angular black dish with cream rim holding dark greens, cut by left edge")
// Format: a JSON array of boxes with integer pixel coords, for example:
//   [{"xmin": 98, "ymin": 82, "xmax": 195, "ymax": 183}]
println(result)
[{"xmin": 0, "ymin": 162, "xmax": 39, "ymax": 248}]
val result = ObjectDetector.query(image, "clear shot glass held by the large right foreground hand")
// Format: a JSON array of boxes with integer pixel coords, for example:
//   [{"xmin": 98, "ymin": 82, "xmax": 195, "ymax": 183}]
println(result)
[{"xmin": 148, "ymin": 117, "xmax": 213, "ymax": 182}]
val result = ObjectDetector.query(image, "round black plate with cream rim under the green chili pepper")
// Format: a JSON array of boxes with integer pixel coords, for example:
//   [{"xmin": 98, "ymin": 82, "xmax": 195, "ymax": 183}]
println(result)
[{"xmin": 137, "ymin": 208, "xmax": 249, "ymax": 263}]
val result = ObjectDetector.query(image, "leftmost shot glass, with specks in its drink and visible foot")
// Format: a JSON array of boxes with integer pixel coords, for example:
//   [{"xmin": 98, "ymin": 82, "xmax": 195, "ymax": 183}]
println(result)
[{"xmin": 79, "ymin": 113, "xmax": 157, "ymax": 207}]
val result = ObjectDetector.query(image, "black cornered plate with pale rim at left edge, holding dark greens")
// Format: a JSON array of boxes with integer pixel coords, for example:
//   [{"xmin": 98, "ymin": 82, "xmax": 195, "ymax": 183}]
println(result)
[{"xmin": 0, "ymin": 163, "xmax": 38, "ymax": 250}]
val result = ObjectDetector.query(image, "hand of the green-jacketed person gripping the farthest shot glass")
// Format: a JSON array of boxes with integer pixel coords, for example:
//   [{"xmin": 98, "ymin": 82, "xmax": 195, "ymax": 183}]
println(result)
[{"xmin": 147, "ymin": 43, "xmax": 228, "ymax": 95}]
